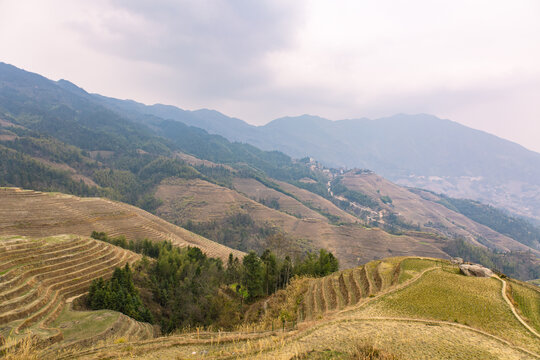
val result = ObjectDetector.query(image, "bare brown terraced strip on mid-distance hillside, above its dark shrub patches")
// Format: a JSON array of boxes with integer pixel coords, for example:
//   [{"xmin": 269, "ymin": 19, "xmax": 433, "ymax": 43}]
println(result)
[{"xmin": 156, "ymin": 179, "xmax": 448, "ymax": 268}]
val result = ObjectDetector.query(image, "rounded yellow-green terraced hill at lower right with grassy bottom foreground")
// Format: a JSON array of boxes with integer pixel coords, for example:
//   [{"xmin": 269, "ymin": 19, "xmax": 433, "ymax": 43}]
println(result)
[{"xmin": 43, "ymin": 258, "xmax": 540, "ymax": 360}]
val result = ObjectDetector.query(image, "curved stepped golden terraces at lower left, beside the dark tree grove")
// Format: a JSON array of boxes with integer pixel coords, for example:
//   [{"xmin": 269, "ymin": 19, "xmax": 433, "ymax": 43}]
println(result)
[{"xmin": 0, "ymin": 235, "xmax": 154, "ymax": 346}]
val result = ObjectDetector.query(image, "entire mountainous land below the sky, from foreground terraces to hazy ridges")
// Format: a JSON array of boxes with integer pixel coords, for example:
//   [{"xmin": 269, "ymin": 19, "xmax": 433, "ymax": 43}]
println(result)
[{"xmin": 0, "ymin": 63, "xmax": 540, "ymax": 359}]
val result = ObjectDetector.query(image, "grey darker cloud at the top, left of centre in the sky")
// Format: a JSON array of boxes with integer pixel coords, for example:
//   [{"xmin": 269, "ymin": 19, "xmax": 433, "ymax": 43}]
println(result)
[{"xmin": 67, "ymin": 0, "xmax": 298, "ymax": 98}]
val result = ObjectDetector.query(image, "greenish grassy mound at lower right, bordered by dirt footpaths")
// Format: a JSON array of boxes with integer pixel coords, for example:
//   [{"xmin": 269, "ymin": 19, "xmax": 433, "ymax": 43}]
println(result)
[{"xmin": 362, "ymin": 268, "xmax": 540, "ymax": 351}]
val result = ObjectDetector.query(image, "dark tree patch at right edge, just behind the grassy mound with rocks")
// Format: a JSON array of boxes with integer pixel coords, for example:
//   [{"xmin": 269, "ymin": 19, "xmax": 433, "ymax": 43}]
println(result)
[{"xmin": 443, "ymin": 238, "xmax": 540, "ymax": 280}]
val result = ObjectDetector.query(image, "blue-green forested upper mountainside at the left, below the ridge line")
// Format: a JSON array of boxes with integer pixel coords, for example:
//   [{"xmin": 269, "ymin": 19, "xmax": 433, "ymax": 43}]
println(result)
[{"xmin": 0, "ymin": 68, "xmax": 324, "ymax": 215}]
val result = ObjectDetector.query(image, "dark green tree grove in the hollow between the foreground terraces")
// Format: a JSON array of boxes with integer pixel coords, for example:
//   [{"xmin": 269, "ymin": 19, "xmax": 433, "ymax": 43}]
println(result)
[{"xmin": 88, "ymin": 231, "xmax": 339, "ymax": 332}]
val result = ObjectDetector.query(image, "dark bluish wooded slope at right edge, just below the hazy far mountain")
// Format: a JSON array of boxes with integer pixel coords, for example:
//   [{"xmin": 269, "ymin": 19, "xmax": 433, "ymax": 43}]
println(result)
[{"xmin": 441, "ymin": 197, "xmax": 540, "ymax": 249}]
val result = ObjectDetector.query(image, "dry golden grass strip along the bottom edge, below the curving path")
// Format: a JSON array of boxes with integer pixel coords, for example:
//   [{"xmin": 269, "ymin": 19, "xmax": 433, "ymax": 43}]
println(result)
[{"xmin": 88, "ymin": 319, "xmax": 532, "ymax": 360}]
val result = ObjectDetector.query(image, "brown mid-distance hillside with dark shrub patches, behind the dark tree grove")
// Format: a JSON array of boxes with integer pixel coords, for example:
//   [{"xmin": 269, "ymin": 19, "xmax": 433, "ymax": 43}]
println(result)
[{"xmin": 152, "ymin": 179, "xmax": 447, "ymax": 268}]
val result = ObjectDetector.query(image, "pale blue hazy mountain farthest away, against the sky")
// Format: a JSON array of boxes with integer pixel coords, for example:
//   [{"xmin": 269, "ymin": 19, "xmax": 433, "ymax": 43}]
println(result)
[{"xmin": 100, "ymin": 95, "xmax": 540, "ymax": 220}]
